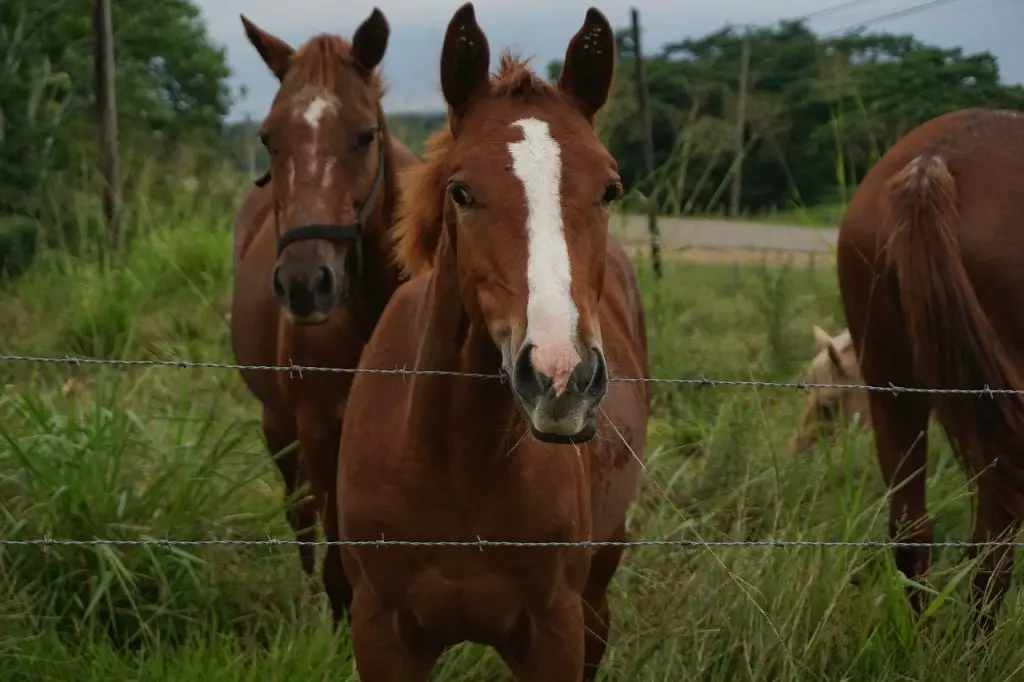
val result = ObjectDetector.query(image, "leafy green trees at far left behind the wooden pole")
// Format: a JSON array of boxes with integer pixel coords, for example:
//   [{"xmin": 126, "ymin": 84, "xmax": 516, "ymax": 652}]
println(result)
[{"xmin": 0, "ymin": 0, "xmax": 232, "ymax": 273}]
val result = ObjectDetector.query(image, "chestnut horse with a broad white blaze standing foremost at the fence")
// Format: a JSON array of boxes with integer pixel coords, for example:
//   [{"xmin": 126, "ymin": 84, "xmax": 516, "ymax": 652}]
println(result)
[{"xmin": 338, "ymin": 3, "xmax": 650, "ymax": 682}]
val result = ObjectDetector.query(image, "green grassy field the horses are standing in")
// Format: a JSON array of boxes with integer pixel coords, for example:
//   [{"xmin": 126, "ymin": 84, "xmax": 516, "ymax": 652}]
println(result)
[{"xmin": 0, "ymin": 187, "xmax": 1024, "ymax": 682}]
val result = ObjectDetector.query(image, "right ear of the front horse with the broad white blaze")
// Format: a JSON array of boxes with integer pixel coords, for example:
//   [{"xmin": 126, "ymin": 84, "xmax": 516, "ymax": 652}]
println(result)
[{"xmin": 558, "ymin": 7, "xmax": 615, "ymax": 121}]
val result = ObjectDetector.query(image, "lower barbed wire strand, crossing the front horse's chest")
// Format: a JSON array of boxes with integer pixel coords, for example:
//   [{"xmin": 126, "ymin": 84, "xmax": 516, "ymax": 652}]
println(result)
[{"xmin": 6, "ymin": 538, "xmax": 1024, "ymax": 551}]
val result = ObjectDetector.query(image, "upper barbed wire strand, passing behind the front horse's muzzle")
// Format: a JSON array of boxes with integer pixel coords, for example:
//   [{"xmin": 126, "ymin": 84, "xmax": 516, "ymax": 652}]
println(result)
[{"xmin": 0, "ymin": 354, "xmax": 1024, "ymax": 397}]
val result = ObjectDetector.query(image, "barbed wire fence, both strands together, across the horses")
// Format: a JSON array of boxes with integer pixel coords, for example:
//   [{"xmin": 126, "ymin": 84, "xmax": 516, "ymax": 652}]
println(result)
[{"xmin": 0, "ymin": 354, "xmax": 1024, "ymax": 551}]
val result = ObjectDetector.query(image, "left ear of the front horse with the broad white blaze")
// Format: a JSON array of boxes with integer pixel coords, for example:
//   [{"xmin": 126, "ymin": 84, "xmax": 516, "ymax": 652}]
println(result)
[{"xmin": 441, "ymin": 2, "xmax": 490, "ymax": 129}]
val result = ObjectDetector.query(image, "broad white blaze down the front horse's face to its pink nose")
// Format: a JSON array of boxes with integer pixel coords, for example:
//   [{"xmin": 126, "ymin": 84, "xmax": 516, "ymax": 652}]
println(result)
[{"xmin": 508, "ymin": 119, "xmax": 580, "ymax": 393}]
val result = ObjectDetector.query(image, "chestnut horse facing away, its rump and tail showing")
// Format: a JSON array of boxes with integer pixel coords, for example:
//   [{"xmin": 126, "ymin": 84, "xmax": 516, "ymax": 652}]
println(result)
[{"xmin": 838, "ymin": 109, "xmax": 1024, "ymax": 632}]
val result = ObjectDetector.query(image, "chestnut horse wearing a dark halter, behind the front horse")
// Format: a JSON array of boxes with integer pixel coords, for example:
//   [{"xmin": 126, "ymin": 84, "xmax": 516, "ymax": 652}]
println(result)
[{"xmin": 231, "ymin": 9, "xmax": 419, "ymax": 622}]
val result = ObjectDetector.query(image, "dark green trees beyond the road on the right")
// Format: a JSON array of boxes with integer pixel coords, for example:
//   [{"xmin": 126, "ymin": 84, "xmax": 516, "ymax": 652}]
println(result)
[{"xmin": 569, "ymin": 22, "xmax": 1024, "ymax": 212}]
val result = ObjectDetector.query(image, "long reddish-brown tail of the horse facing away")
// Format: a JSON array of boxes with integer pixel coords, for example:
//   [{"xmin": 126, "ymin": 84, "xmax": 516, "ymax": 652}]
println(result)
[{"xmin": 885, "ymin": 155, "xmax": 1024, "ymax": 511}]
